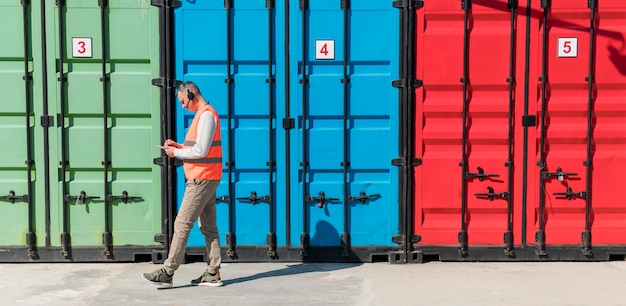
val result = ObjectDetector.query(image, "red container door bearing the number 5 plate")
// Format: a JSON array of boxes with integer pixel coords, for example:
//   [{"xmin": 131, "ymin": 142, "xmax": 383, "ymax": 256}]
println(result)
[{"xmin": 528, "ymin": 1, "xmax": 626, "ymax": 256}]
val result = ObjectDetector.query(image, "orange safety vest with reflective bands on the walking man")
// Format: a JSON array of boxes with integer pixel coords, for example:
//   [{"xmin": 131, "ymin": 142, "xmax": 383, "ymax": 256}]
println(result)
[{"xmin": 183, "ymin": 104, "xmax": 222, "ymax": 181}]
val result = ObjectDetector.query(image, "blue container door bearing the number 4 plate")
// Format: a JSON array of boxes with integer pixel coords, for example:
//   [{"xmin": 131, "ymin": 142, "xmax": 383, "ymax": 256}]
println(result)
[{"xmin": 290, "ymin": 1, "xmax": 399, "ymax": 255}]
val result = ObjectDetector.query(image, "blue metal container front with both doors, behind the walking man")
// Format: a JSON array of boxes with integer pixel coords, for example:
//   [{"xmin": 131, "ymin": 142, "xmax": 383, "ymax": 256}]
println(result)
[{"xmin": 175, "ymin": 0, "xmax": 399, "ymax": 256}]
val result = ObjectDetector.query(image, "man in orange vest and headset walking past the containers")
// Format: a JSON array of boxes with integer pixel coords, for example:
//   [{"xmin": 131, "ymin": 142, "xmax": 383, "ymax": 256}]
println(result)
[{"xmin": 143, "ymin": 82, "xmax": 222, "ymax": 287}]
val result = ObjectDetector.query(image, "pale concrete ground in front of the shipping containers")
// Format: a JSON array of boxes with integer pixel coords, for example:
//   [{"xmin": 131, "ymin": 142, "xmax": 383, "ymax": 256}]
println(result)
[{"xmin": 0, "ymin": 261, "xmax": 626, "ymax": 306}]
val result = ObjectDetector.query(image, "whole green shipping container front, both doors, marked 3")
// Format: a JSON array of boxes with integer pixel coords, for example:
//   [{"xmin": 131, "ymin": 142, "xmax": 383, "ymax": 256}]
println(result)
[{"xmin": 0, "ymin": 0, "xmax": 173, "ymax": 262}]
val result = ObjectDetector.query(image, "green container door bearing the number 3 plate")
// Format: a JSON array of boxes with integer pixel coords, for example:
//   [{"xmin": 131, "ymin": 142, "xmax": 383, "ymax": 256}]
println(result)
[{"xmin": 46, "ymin": 1, "xmax": 161, "ymax": 258}]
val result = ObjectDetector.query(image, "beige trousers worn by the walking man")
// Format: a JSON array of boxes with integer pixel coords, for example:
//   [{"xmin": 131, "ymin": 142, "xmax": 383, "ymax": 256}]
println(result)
[{"xmin": 163, "ymin": 179, "xmax": 222, "ymax": 275}]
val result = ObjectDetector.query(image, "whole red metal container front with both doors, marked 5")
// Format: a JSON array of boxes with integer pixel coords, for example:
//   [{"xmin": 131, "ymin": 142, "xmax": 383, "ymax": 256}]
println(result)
[{"xmin": 414, "ymin": 0, "xmax": 626, "ymax": 253}]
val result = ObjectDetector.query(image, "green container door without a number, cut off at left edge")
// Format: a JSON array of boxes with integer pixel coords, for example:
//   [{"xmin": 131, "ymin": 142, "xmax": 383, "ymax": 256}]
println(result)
[{"xmin": 0, "ymin": 1, "xmax": 36, "ymax": 250}]
